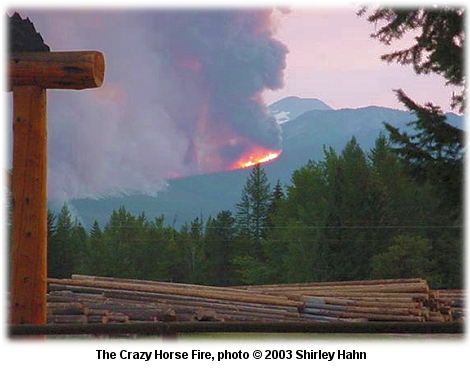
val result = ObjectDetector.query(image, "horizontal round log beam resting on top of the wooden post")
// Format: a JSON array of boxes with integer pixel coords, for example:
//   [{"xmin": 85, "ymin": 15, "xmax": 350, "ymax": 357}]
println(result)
[{"xmin": 8, "ymin": 51, "xmax": 105, "ymax": 91}]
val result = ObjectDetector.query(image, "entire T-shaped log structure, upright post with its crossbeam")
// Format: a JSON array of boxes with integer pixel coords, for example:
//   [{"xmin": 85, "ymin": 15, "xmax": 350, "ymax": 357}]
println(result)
[{"xmin": 9, "ymin": 51, "xmax": 104, "ymax": 324}]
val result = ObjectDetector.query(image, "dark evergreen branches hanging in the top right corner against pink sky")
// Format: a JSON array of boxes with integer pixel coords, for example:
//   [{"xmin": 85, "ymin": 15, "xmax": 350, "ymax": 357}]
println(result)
[{"xmin": 358, "ymin": 6, "xmax": 465, "ymax": 113}]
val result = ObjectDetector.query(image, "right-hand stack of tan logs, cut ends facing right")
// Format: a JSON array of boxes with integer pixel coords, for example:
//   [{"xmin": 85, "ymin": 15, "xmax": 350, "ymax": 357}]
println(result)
[{"xmin": 237, "ymin": 278, "xmax": 451, "ymax": 322}]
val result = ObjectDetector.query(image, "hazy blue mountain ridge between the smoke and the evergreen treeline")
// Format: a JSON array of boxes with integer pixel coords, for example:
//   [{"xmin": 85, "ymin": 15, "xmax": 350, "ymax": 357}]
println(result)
[{"xmin": 51, "ymin": 99, "xmax": 463, "ymax": 229}]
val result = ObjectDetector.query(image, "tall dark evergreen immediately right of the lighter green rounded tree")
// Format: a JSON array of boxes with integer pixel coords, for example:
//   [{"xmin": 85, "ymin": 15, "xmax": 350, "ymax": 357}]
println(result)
[{"xmin": 312, "ymin": 137, "xmax": 380, "ymax": 280}]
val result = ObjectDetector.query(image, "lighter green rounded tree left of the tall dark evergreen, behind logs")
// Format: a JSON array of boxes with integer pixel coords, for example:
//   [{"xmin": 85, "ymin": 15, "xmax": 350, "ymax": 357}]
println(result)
[{"xmin": 268, "ymin": 161, "xmax": 327, "ymax": 282}]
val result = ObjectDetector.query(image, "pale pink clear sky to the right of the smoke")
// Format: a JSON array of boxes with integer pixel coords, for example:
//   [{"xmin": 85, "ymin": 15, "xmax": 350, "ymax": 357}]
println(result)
[{"xmin": 266, "ymin": 5, "xmax": 453, "ymax": 111}]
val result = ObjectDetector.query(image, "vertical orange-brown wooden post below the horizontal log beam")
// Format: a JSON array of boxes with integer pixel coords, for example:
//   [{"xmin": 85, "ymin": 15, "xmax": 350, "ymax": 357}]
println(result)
[{"xmin": 10, "ymin": 86, "xmax": 47, "ymax": 324}]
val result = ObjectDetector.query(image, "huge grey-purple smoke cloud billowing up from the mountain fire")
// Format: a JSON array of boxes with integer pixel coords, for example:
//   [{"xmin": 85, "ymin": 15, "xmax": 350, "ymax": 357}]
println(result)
[{"xmin": 9, "ymin": 9, "xmax": 287, "ymax": 199}]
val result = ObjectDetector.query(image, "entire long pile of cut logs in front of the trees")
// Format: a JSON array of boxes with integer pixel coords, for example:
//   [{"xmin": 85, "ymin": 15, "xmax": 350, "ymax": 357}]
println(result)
[{"xmin": 47, "ymin": 275, "xmax": 464, "ymax": 324}]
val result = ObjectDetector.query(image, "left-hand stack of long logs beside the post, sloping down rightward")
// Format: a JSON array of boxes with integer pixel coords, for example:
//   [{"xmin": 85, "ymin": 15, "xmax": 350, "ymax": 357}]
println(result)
[{"xmin": 48, "ymin": 275, "xmax": 302, "ymax": 322}]
